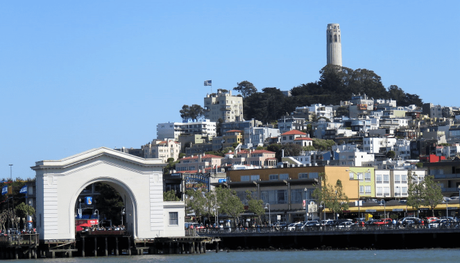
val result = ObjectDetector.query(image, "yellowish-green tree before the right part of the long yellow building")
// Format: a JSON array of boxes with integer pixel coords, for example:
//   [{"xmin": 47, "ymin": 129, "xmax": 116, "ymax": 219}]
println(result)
[{"xmin": 313, "ymin": 173, "xmax": 349, "ymax": 220}]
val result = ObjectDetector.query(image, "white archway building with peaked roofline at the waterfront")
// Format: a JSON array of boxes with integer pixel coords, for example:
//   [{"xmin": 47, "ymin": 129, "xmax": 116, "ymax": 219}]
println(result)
[{"xmin": 31, "ymin": 147, "xmax": 185, "ymax": 240}]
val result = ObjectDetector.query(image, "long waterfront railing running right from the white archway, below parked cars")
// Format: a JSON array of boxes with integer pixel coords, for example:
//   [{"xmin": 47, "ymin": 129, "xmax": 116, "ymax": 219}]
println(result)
[{"xmin": 192, "ymin": 222, "xmax": 460, "ymax": 236}]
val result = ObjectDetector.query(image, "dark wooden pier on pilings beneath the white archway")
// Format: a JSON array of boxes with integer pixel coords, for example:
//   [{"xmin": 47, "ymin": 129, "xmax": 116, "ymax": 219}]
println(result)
[{"xmin": 0, "ymin": 231, "xmax": 220, "ymax": 259}]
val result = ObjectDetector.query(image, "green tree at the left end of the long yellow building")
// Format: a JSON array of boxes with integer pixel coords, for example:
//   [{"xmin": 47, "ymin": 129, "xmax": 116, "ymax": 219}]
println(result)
[{"xmin": 216, "ymin": 186, "xmax": 244, "ymax": 227}]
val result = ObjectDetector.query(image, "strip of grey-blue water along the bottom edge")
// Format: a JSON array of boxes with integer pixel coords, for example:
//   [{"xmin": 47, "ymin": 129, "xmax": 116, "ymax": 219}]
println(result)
[{"xmin": 11, "ymin": 249, "xmax": 460, "ymax": 263}]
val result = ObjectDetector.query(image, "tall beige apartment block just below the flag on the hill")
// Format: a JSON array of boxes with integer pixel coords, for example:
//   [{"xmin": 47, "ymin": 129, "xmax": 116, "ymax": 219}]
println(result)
[{"xmin": 204, "ymin": 89, "xmax": 243, "ymax": 122}]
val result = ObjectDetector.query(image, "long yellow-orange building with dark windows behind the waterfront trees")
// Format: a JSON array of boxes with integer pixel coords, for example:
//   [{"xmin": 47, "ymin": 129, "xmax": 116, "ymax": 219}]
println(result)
[{"xmin": 227, "ymin": 166, "xmax": 358, "ymax": 222}]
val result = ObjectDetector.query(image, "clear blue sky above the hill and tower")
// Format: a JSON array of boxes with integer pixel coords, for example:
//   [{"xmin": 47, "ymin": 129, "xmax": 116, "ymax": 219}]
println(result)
[{"xmin": 0, "ymin": 0, "xmax": 460, "ymax": 178}]
